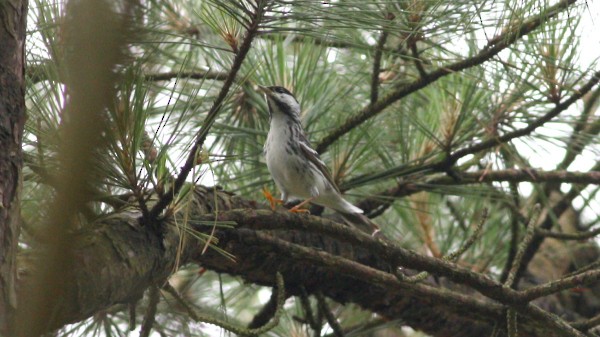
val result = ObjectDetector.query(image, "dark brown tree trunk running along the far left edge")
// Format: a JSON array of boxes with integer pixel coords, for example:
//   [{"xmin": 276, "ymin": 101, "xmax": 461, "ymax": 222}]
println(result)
[{"xmin": 0, "ymin": 0, "xmax": 27, "ymax": 335}]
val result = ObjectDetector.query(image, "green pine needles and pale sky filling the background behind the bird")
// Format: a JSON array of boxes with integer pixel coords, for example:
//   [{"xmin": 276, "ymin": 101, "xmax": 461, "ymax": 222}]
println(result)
[{"xmin": 22, "ymin": 0, "xmax": 600, "ymax": 336}]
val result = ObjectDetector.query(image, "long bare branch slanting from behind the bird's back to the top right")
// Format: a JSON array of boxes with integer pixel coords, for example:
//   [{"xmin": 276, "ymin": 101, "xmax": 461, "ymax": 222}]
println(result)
[{"xmin": 315, "ymin": 0, "xmax": 579, "ymax": 153}]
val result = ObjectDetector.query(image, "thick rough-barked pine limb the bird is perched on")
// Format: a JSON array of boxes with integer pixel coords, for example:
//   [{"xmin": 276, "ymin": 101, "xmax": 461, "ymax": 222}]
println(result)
[{"xmin": 17, "ymin": 187, "xmax": 596, "ymax": 336}]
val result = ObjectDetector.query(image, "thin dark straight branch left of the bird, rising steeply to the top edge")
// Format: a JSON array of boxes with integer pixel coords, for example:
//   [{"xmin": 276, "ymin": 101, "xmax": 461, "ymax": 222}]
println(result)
[{"xmin": 145, "ymin": 0, "xmax": 266, "ymax": 224}]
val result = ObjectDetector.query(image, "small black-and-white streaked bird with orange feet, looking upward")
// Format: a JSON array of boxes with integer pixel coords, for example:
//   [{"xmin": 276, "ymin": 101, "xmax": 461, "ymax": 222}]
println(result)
[{"xmin": 258, "ymin": 85, "xmax": 379, "ymax": 235}]
